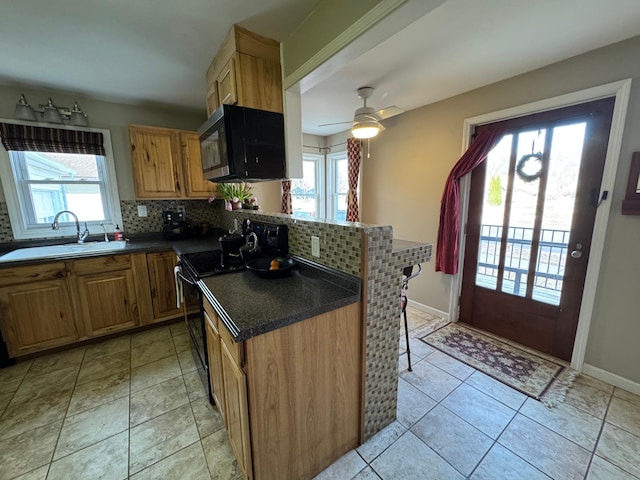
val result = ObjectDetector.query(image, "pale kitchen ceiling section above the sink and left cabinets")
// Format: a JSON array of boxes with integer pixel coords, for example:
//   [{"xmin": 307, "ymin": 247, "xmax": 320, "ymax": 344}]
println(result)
[{"xmin": 0, "ymin": 0, "xmax": 319, "ymax": 110}]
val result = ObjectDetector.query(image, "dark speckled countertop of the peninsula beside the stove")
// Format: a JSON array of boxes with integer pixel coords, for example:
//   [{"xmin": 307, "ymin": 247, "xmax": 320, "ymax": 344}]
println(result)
[{"xmin": 198, "ymin": 256, "xmax": 361, "ymax": 341}]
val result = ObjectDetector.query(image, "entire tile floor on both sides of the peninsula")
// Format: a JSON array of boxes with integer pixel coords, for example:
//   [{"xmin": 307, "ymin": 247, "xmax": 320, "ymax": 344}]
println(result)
[{"xmin": 0, "ymin": 308, "xmax": 640, "ymax": 480}]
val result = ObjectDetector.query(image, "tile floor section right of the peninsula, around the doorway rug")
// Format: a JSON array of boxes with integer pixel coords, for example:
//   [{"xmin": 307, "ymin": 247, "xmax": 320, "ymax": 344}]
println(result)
[{"xmin": 316, "ymin": 307, "xmax": 640, "ymax": 480}]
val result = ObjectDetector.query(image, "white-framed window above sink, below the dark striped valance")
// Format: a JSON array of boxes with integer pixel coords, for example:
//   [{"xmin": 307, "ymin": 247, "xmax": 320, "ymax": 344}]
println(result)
[{"xmin": 0, "ymin": 122, "xmax": 122, "ymax": 239}]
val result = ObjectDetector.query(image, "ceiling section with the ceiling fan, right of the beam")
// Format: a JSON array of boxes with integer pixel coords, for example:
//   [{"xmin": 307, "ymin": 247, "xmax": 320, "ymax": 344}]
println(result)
[{"xmin": 302, "ymin": 0, "xmax": 640, "ymax": 135}]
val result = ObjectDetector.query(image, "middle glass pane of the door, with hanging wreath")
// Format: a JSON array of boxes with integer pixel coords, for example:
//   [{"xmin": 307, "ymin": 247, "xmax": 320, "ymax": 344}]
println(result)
[{"xmin": 502, "ymin": 129, "xmax": 546, "ymax": 297}]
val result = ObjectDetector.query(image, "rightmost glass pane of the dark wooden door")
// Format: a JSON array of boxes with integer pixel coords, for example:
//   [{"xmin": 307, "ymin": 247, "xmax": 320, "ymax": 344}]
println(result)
[{"xmin": 532, "ymin": 122, "xmax": 586, "ymax": 305}]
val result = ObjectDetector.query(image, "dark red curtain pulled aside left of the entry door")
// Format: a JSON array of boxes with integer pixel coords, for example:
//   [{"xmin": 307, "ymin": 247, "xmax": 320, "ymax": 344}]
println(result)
[{"xmin": 436, "ymin": 129, "xmax": 504, "ymax": 275}]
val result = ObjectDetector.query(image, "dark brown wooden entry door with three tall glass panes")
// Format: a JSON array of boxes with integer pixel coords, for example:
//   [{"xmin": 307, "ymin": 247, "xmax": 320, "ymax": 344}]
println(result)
[{"xmin": 459, "ymin": 98, "xmax": 614, "ymax": 361}]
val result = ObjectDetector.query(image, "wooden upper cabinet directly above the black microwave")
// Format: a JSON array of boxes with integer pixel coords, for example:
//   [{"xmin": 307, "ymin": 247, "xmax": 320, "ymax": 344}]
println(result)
[{"xmin": 205, "ymin": 25, "xmax": 282, "ymax": 116}]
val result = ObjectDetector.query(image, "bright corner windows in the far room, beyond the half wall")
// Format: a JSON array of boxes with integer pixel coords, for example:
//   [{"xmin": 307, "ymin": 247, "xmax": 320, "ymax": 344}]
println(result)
[{"xmin": 291, "ymin": 151, "xmax": 359, "ymax": 221}]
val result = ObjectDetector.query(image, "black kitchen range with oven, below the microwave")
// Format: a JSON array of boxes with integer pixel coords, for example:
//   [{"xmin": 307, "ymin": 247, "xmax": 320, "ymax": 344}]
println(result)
[{"xmin": 176, "ymin": 220, "xmax": 289, "ymax": 402}]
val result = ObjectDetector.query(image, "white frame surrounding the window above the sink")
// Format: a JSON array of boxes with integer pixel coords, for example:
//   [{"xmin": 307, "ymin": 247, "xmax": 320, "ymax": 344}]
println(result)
[{"xmin": 0, "ymin": 119, "xmax": 122, "ymax": 240}]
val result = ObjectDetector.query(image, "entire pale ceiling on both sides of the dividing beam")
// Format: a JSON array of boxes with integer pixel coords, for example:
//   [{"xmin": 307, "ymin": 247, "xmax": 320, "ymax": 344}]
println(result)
[{"xmin": 0, "ymin": 0, "xmax": 640, "ymax": 135}]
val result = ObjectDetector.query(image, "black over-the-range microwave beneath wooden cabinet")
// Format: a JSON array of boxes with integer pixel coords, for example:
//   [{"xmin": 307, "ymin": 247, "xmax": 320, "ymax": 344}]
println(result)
[{"xmin": 198, "ymin": 104, "xmax": 286, "ymax": 182}]
